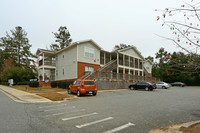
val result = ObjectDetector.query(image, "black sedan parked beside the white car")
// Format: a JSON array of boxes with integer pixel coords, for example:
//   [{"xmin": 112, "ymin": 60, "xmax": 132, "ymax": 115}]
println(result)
[{"xmin": 129, "ymin": 82, "xmax": 156, "ymax": 91}]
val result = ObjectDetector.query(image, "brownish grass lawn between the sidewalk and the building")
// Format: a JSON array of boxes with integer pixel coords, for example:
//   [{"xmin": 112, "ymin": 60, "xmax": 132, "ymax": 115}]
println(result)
[{"xmin": 12, "ymin": 85, "xmax": 74, "ymax": 101}]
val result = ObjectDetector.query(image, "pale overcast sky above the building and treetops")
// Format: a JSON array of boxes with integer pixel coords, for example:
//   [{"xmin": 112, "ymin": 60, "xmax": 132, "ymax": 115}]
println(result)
[{"xmin": 0, "ymin": 0, "xmax": 182, "ymax": 57}]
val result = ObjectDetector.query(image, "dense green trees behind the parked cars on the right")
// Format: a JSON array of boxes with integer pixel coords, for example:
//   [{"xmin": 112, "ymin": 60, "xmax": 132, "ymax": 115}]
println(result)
[{"xmin": 152, "ymin": 48, "xmax": 200, "ymax": 86}]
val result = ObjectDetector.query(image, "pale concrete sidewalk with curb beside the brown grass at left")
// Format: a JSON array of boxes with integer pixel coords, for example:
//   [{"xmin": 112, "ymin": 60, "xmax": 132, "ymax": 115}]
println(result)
[{"xmin": 0, "ymin": 85, "xmax": 51, "ymax": 103}]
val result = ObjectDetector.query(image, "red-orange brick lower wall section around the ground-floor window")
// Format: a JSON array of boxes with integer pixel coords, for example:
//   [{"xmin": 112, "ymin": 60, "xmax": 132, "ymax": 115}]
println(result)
[{"xmin": 77, "ymin": 62, "xmax": 100, "ymax": 79}]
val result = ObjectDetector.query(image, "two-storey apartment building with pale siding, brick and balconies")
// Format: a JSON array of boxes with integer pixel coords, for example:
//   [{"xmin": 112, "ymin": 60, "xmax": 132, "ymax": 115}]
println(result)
[{"xmin": 36, "ymin": 40, "xmax": 152, "ymax": 81}]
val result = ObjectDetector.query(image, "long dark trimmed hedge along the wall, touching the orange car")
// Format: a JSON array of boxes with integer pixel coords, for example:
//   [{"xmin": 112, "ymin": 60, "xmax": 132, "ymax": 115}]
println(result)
[{"xmin": 51, "ymin": 81, "xmax": 74, "ymax": 89}]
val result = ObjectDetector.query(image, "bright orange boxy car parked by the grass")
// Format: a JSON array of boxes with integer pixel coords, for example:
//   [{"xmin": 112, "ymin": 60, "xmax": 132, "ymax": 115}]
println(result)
[{"xmin": 68, "ymin": 80, "xmax": 97, "ymax": 97}]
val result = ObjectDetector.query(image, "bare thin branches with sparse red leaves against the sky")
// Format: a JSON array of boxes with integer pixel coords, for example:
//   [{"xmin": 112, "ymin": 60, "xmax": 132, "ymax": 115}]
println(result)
[{"xmin": 157, "ymin": 0, "xmax": 200, "ymax": 54}]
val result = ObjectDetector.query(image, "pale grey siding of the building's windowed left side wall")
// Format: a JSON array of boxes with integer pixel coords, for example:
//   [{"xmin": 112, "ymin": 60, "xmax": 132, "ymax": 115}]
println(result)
[{"xmin": 56, "ymin": 45, "xmax": 77, "ymax": 80}]
